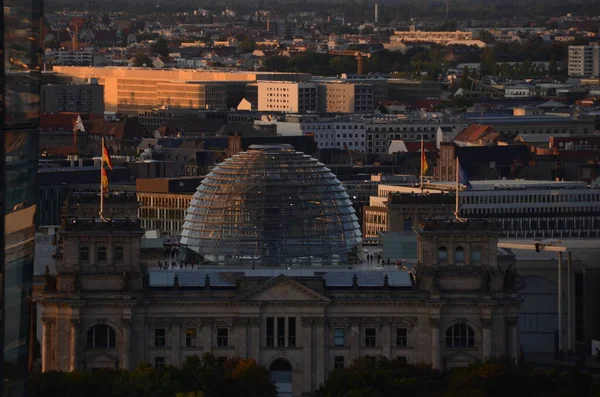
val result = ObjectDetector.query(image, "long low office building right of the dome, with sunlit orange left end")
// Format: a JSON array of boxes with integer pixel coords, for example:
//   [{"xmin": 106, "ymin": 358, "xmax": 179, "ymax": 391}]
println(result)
[{"xmin": 364, "ymin": 180, "xmax": 600, "ymax": 239}]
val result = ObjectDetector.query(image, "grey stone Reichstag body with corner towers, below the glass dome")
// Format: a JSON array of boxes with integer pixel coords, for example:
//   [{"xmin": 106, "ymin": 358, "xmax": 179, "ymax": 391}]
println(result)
[{"xmin": 35, "ymin": 193, "xmax": 520, "ymax": 396}]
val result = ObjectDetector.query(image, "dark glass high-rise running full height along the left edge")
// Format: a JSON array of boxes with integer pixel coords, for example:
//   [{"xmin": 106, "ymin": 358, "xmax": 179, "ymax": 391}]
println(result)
[{"xmin": 0, "ymin": 0, "xmax": 42, "ymax": 397}]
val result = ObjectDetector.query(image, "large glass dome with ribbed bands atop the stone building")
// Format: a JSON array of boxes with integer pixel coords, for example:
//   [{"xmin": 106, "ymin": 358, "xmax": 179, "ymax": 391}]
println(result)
[{"xmin": 181, "ymin": 145, "xmax": 362, "ymax": 266}]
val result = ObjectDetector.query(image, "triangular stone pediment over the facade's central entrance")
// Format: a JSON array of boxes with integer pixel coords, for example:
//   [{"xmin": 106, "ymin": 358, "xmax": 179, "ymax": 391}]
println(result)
[{"xmin": 234, "ymin": 275, "xmax": 330, "ymax": 303}]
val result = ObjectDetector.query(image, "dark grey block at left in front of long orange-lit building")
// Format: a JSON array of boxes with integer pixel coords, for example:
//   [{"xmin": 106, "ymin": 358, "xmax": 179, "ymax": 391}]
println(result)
[{"xmin": 40, "ymin": 83, "xmax": 104, "ymax": 118}]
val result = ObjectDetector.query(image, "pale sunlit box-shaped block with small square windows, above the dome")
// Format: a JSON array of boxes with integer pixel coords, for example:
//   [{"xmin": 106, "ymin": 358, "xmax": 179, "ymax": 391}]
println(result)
[{"xmin": 257, "ymin": 81, "xmax": 319, "ymax": 113}]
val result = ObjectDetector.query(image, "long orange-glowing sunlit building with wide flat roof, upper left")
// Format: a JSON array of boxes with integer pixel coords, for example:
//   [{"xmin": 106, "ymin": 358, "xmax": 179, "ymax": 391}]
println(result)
[{"xmin": 54, "ymin": 66, "xmax": 310, "ymax": 115}]
